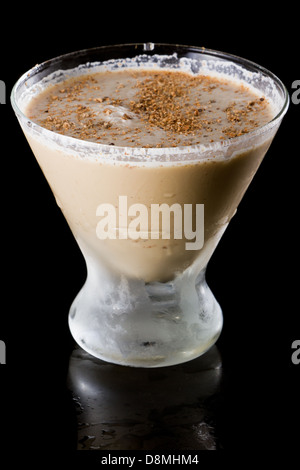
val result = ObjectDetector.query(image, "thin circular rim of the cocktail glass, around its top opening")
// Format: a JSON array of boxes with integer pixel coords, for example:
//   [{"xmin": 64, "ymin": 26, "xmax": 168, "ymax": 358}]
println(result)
[{"xmin": 10, "ymin": 43, "xmax": 289, "ymax": 163}]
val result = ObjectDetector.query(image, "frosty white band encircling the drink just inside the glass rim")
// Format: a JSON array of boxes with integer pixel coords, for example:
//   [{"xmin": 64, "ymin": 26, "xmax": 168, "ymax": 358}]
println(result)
[{"xmin": 16, "ymin": 53, "xmax": 282, "ymax": 166}]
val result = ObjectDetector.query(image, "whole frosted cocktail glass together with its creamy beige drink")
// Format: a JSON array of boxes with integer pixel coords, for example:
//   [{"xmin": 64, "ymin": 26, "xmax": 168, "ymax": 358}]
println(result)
[{"xmin": 13, "ymin": 45, "xmax": 287, "ymax": 367}]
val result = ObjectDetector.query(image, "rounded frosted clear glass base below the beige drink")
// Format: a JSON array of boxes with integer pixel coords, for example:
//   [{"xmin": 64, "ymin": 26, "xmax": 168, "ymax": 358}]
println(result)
[{"xmin": 69, "ymin": 271, "xmax": 223, "ymax": 367}]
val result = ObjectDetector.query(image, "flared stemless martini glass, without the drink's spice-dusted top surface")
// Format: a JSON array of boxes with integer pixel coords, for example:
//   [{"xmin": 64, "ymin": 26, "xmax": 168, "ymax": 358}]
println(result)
[{"xmin": 11, "ymin": 43, "xmax": 289, "ymax": 367}]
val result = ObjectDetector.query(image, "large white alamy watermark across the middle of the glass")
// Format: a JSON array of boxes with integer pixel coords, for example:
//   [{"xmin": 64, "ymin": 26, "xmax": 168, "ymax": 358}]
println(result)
[{"xmin": 96, "ymin": 196, "xmax": 204, "ymax": 250}]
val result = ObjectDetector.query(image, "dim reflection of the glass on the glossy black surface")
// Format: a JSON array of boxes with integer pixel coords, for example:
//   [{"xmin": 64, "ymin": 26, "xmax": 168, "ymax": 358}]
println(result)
[{"xmin": 68, "ymin": 346, "xmax": 222, "ymax": 450}]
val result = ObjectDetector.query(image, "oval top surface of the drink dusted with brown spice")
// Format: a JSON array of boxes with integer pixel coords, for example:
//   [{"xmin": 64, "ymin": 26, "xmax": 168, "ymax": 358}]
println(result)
[{"xmin": 26, "ymin": 69, "xmax": 273, "ymax": 147}]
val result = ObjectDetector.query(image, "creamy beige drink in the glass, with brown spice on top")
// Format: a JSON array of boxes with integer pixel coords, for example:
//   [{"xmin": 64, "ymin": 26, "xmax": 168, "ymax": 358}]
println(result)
[{"xmin": 22, "ymin": 67, "xmax": 273, "ymax": 282}]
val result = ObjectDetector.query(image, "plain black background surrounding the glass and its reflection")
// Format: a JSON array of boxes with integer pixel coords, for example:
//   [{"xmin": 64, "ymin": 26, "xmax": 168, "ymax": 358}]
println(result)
[{"xmin": 0, "ymin": 3, "xmax": 300, "ymax": 459}]
